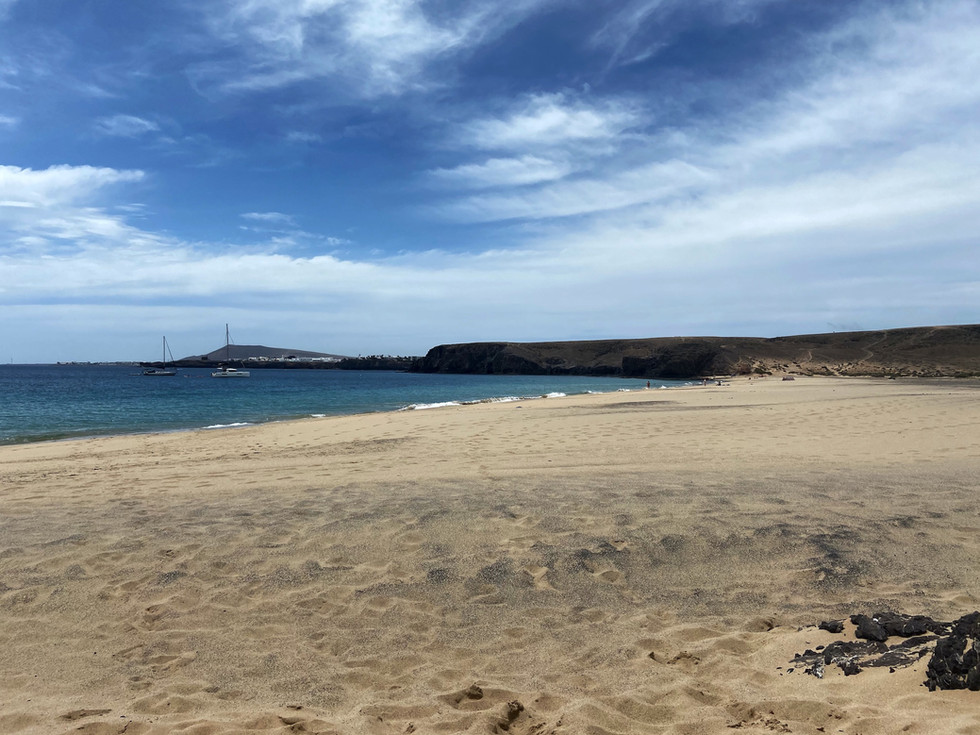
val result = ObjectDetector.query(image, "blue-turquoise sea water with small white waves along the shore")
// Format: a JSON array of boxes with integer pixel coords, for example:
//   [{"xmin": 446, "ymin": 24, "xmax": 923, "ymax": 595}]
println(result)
[{"xmin": 0, "ymin": 365, "xmax": 684, "ymax": 444}]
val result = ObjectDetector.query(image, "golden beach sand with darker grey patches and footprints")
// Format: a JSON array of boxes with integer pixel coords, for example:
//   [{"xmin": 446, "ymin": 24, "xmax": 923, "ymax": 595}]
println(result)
[{"xmin": 0, "ymin": 378, "xmax": 980, "ymax": 735}]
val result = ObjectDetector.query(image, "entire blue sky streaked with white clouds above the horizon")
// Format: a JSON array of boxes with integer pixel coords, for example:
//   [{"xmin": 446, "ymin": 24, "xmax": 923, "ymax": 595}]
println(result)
[{"xmin": 0, "ymin": 0, "xmax": 980, "ymax": 363}]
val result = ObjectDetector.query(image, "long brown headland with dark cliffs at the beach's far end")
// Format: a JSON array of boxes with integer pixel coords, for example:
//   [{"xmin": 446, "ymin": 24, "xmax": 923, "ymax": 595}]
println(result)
[{"xmin": 413, "ymin": 324, "xmax": 980, "ymax": 378}]
